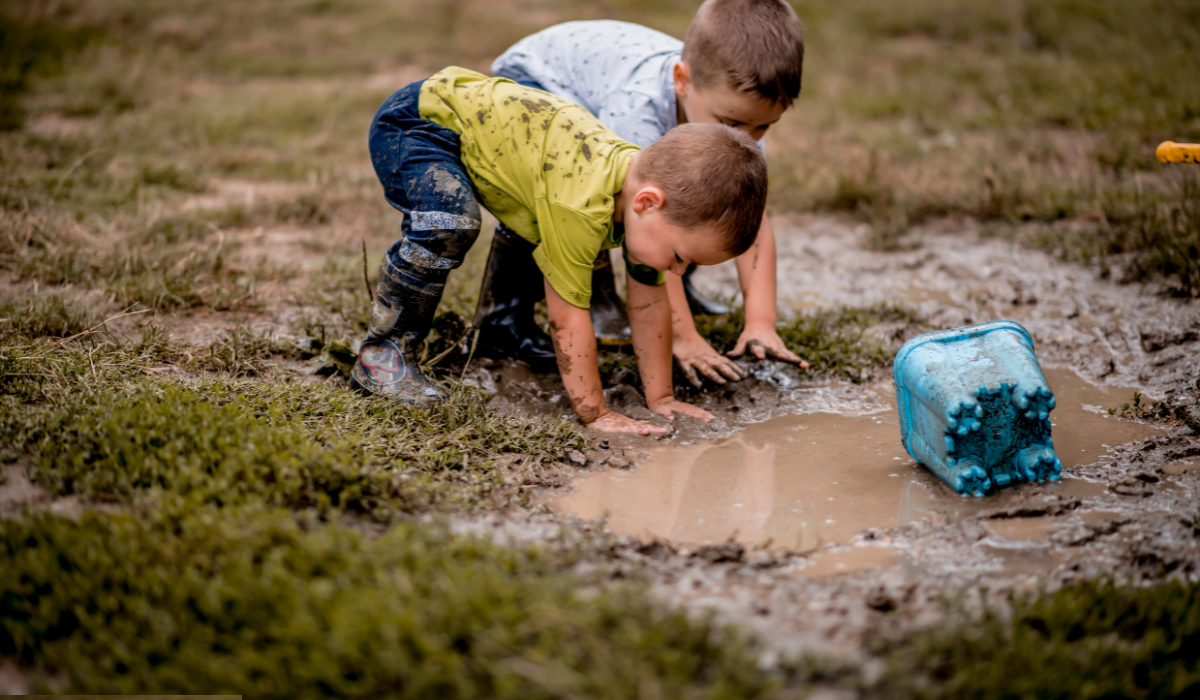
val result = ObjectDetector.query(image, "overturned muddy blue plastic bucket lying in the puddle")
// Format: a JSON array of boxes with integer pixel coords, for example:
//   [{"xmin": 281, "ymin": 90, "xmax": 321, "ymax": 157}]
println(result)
[{"xmin": 893, "ymin": 321, "xmax": 1062, "ymax": 496}]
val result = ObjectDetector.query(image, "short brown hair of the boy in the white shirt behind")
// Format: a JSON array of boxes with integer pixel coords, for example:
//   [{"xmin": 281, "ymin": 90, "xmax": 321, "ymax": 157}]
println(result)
[{"xmin": 683, "ymin": 0, "xmax": 804, "ymax": 108}]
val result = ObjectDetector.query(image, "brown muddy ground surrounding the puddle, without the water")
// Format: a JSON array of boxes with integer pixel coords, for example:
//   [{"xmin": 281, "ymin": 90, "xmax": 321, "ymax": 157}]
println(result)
[{"xmin": 439, "ymin": 216, "xmax": 1200, "ymax": 693}]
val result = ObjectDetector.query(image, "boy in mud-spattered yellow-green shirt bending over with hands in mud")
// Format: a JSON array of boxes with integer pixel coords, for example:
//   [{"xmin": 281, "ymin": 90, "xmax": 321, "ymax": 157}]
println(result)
[{"xmin": 352, "ymin": 67, "xmax": 767, "ymax": 435}]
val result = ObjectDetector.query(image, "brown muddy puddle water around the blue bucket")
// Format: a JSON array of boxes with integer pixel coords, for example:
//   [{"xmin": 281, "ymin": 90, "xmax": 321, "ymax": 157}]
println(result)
[{"xmin": 551, "ymin": 369, "xmax": 1162, "ymax": 576}]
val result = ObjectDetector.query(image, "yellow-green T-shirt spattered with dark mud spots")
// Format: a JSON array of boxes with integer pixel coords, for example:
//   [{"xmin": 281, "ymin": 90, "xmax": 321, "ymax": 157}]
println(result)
[{"xmin": 419, "ymin": 66, "xmax": 662, "ymax": 309}]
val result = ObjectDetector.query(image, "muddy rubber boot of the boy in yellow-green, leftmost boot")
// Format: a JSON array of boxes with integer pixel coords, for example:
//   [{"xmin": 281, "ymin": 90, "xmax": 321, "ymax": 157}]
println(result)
[{"xmin": 350, "ymin": 255, "xmax": 446, "ymax": 405}]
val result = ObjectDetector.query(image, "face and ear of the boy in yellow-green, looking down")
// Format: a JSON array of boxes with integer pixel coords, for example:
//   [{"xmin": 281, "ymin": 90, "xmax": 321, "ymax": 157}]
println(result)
[{"xmin": 624, "ymin": 186, "xmax": 733, "ymax": 275}]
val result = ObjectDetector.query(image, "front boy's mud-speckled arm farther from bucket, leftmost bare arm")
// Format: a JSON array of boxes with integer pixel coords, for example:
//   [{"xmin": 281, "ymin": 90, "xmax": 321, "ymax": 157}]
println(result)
[{"xmin": 546, "ymin": 281, "xmax": 670, "ymax": 435}]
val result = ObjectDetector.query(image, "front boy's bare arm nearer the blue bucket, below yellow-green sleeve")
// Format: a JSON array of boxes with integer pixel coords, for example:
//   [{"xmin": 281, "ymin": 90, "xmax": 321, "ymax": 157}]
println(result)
[{"xmin": 625, "ymin": 275, "xmax": 715, "ymax": 423}]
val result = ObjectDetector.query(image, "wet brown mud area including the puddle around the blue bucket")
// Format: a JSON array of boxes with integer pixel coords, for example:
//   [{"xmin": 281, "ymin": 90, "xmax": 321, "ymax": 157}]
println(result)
[{"xmin": 451, "ymin": 217, "xmax": 1200, "ymax": 677}]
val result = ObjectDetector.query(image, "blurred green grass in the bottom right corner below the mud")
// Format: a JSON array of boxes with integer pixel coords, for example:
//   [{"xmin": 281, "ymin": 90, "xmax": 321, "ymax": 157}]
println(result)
[{"xmin": 887, "ymin": 581, "xmax": 1200, "ymax": 699}]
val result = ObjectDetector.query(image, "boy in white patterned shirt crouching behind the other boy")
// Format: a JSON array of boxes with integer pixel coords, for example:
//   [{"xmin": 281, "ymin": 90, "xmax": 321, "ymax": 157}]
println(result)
[{"xmin": 475, "ymin": 0, "xmax": 808, "ymax": 387}]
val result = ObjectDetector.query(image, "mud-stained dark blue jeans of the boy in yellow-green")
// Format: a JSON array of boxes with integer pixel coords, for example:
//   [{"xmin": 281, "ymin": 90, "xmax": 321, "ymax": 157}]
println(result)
[{"xmin": 367, "ymin": 80, "xmax": 480, "ymax": 290}]
